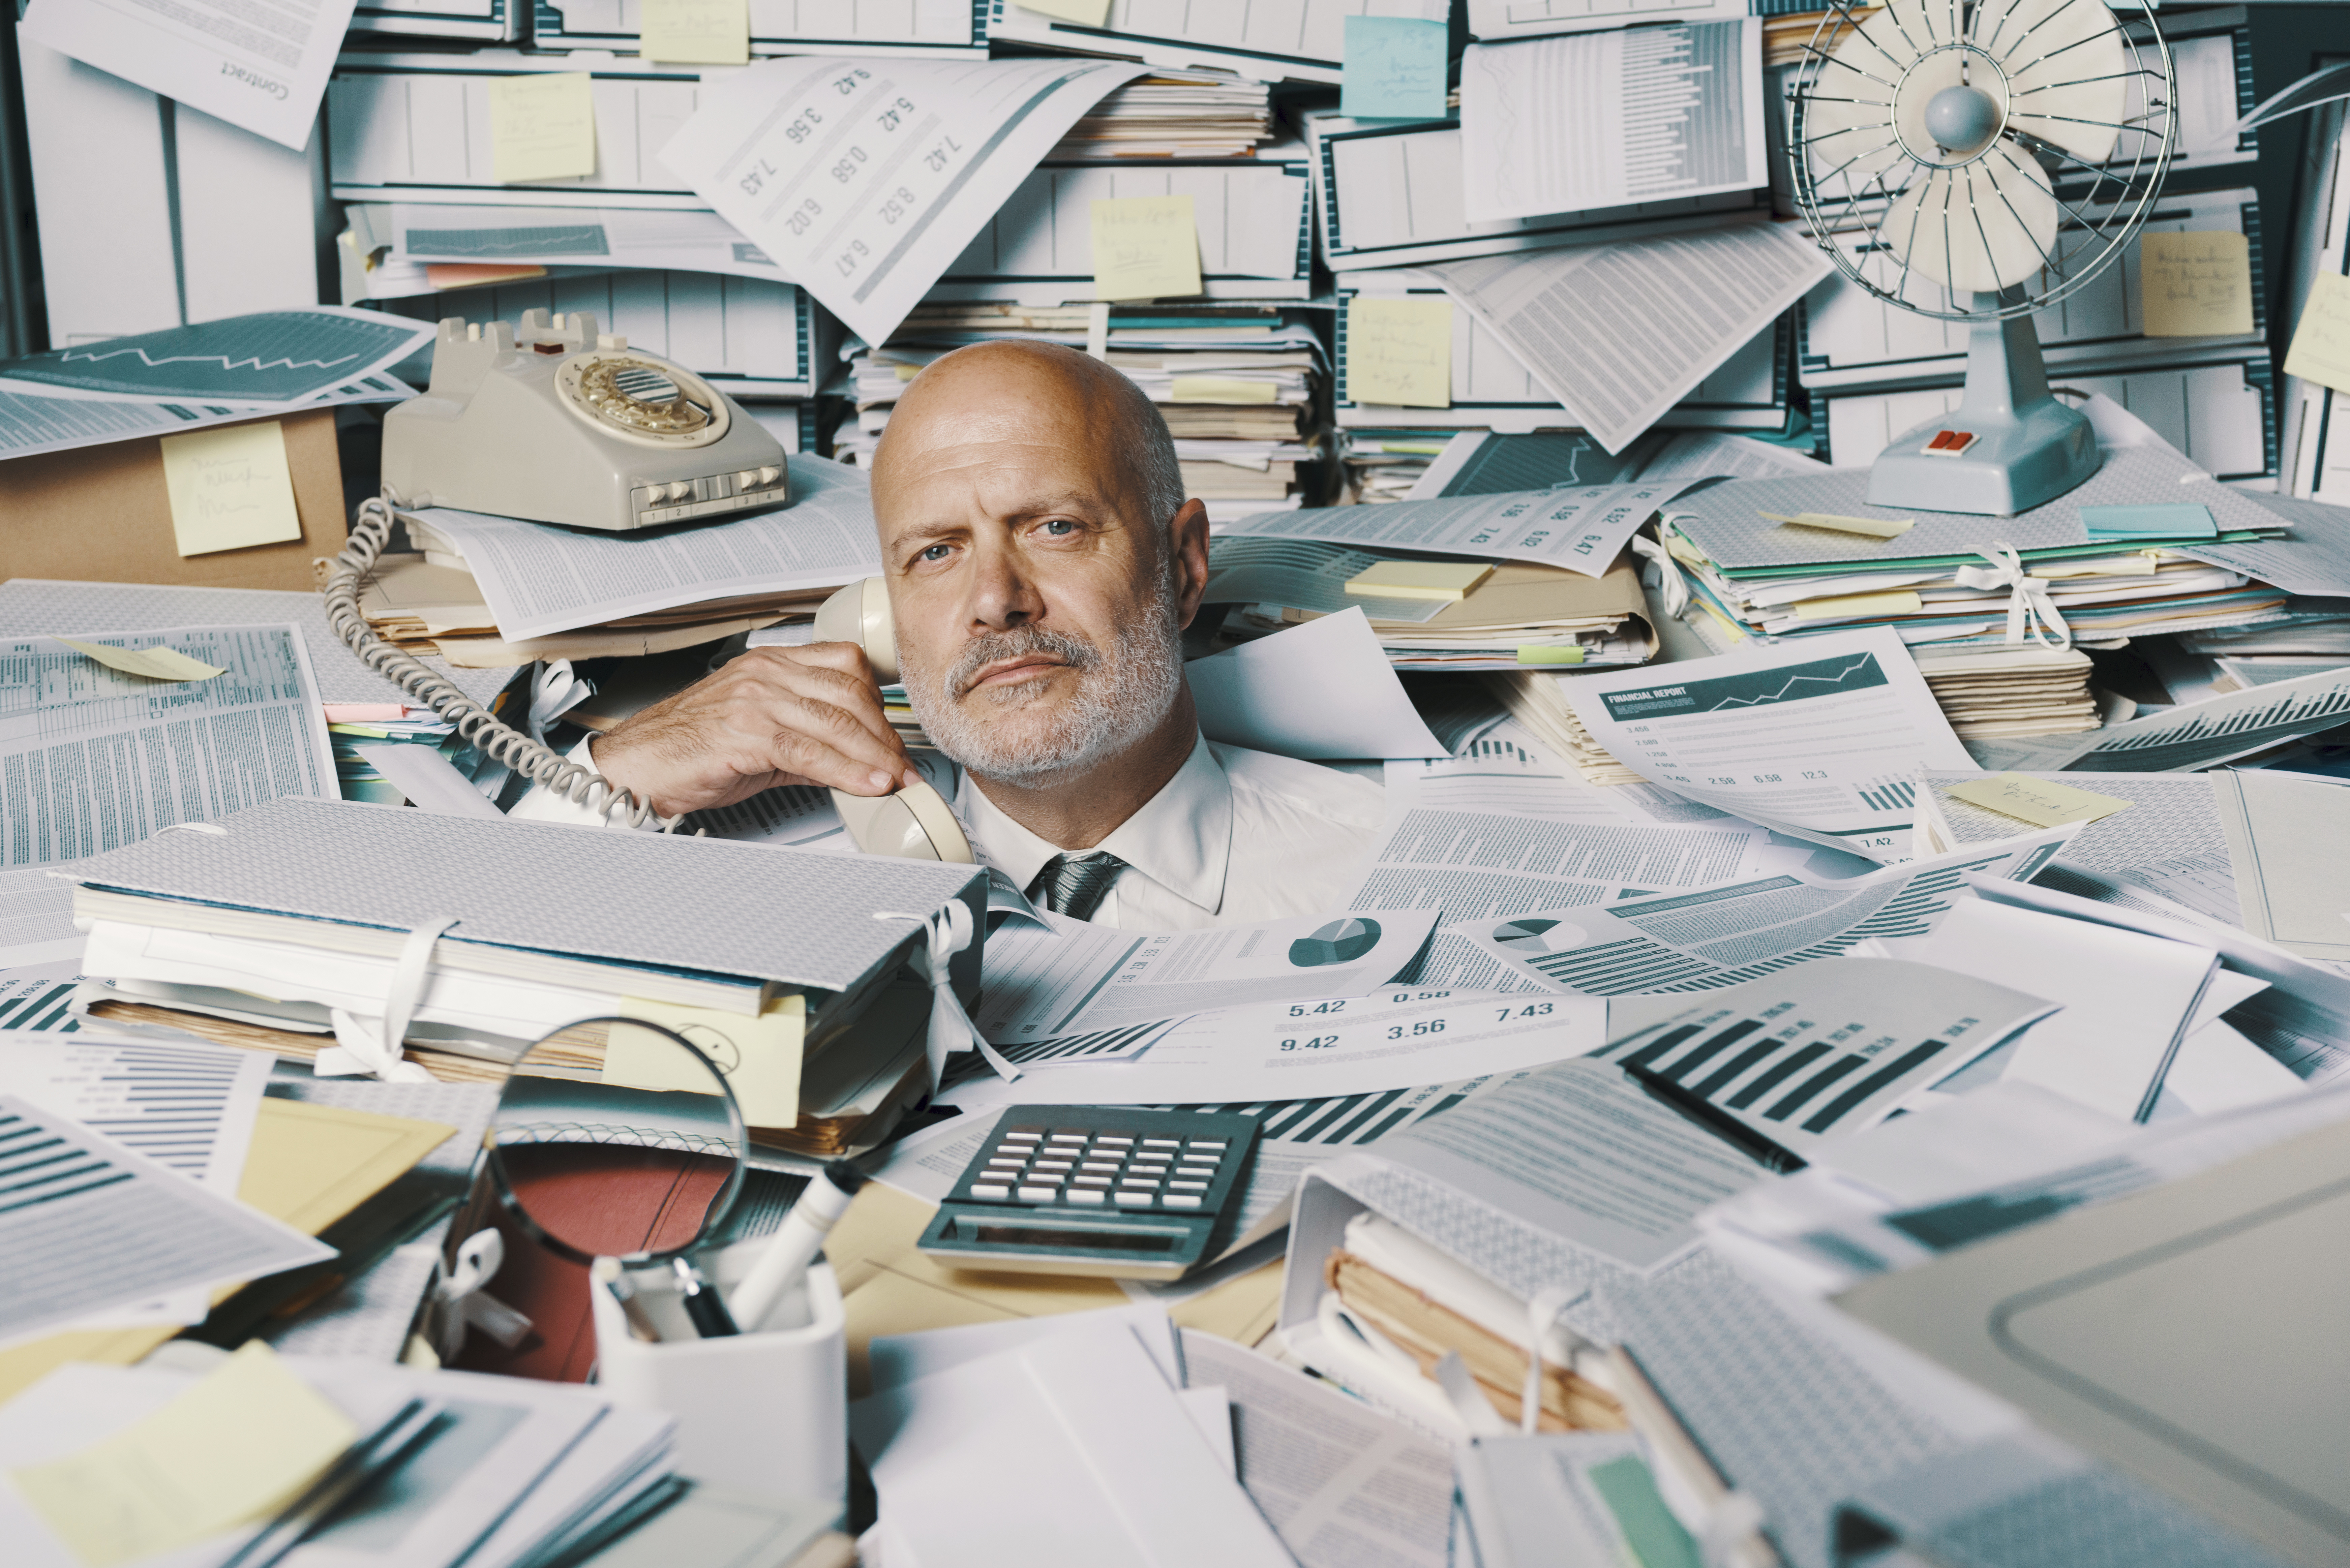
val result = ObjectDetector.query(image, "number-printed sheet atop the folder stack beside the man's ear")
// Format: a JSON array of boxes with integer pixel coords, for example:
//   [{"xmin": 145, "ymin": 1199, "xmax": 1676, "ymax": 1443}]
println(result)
[{"xmin": 1222, "ymin": 480, "xmax": 1690, "ymax": 576}]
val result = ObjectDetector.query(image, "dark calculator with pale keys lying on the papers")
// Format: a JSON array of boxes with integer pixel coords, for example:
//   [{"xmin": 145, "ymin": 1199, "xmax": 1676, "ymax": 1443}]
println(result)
[{"xmin": 921, "ymin": 1105, "xmax": 1257, "ymax": 1279}]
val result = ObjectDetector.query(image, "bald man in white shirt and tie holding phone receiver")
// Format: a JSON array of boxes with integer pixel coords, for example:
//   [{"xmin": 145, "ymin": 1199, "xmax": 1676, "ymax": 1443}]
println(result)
[{"xmin": 515, "ymin": 343, "xmax": 1384, "ymax": 931}]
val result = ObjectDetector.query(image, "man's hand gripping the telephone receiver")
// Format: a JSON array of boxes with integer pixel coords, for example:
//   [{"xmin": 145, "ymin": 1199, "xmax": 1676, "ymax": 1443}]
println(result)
[{"xmin": 590, "ymin": 642, "xmax": 921, "ymax": 816}]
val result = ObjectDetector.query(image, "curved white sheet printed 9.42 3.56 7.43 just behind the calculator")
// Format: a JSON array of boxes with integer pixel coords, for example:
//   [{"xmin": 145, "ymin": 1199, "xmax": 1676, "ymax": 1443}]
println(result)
[{"xmin": 947, "ymin": 987, "xmax": 1607, "ymax": 1105}]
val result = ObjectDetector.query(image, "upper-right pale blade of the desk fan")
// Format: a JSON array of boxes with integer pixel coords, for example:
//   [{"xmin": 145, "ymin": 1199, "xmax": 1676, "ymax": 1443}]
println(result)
[{"xmin": 1974, "ymin": 0, "xmax": 2129, "ymax": 162}]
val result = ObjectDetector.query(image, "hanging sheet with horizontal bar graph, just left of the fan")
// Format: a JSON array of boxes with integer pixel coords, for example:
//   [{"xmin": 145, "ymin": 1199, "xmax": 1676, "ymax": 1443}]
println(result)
[{"xmin": 1447, "ymin": 21, "xmax": 1770, "ymax": 222}]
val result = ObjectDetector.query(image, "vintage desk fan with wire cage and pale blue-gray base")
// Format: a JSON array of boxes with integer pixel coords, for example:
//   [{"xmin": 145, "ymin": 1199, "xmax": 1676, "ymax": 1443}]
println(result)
[{"xmin": 1788, "ymin": 0, "xmax": 2176, "ymax": 517}]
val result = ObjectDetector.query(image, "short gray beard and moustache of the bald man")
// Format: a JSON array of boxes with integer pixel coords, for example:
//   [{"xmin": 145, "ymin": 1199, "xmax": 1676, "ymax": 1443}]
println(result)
[{"xmin": 898, "ymin": 597, "xmax": 1182, "ymax": 790}]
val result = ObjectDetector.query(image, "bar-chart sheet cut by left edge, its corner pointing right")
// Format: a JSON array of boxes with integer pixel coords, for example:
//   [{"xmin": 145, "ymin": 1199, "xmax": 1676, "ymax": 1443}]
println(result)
[{"xmin": 0, "ymin": 1093, "xmax": 334, "ymax": 1345}]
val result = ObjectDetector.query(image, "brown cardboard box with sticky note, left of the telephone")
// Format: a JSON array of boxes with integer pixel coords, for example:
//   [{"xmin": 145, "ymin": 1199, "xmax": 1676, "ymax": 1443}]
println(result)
[{"xmin": 0, "ymin": 409, "xmax": 348, "ymax": 592}]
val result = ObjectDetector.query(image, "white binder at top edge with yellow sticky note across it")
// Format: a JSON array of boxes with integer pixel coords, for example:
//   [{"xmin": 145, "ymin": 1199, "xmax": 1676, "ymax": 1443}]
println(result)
[{"xmin": 536, "ymin": 0, "xmax": 994, "ymax": 59}]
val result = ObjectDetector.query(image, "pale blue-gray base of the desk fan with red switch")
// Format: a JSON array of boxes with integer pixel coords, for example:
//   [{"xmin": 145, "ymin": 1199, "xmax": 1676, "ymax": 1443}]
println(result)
[{"xmin": 1868, "ymin": 395, "xmax": 2101, "ymax": 517}]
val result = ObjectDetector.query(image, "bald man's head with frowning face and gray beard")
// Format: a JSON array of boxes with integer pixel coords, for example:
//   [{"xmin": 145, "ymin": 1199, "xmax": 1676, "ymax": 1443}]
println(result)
[{"xmin": 874, "ymin": 367, "xmax": 1206, "ymax": 785}]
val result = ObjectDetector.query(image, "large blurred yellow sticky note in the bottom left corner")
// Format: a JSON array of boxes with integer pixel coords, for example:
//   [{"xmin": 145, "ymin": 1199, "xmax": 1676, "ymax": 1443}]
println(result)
[{"xmin": 9, "ymin": 1340, "xmax": 360, "ymax": 1568}]
